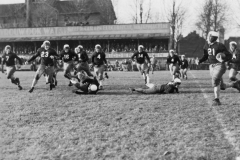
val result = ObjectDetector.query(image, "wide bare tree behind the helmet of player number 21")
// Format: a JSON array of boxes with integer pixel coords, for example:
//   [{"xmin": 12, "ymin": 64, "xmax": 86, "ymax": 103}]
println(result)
[{"xmin": 196, "ymin": 0, "xmax": 228, "ymax": 38}]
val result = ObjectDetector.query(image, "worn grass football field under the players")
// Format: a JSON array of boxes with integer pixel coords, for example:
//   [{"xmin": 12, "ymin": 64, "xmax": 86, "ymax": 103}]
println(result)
[{"xmin": 0, "ymin": 71, "xmax": 240, "ymax": 160}]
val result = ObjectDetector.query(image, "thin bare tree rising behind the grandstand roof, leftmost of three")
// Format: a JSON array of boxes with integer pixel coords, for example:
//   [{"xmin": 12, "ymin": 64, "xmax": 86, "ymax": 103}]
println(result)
[{"xmin": 131, "ymin": 0, "xmax": 152, "ymax": 24}]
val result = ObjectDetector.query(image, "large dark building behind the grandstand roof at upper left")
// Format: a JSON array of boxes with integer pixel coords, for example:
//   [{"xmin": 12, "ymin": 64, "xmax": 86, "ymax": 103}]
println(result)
[{"xmin": 0, "ymin": 0, "xmax": 116, "ymax": 28}]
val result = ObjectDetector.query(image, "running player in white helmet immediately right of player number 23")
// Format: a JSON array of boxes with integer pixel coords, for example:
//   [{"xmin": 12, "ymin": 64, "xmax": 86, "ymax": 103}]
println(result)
[{"xmin": 60, "ymin": 44, "xmax": 78, "ymax": 86}]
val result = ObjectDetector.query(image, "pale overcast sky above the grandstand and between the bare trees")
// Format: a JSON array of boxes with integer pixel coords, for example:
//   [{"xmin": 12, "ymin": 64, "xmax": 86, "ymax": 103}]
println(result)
[{"xmin": 0, "ymin": 0, "xmax": 240, "ymax": 38}]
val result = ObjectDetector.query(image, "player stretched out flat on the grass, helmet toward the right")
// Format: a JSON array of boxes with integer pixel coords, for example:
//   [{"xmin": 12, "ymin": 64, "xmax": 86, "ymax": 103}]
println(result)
[{"xmin": 129, "ymin": 78, "xmax": 181, "ymax": 94}]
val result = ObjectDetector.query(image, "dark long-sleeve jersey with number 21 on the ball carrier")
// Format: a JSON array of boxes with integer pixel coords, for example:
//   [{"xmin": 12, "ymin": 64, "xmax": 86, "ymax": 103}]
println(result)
[{"xmin": 199, "ymin": 42, "xmax": 232, "ymax": 64}]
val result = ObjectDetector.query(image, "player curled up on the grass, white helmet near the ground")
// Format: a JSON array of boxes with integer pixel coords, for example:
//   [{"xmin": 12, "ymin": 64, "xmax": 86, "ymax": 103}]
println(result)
[{"xmin": 71, "ymin": 71, "xmax": 99, "ymax": 94}]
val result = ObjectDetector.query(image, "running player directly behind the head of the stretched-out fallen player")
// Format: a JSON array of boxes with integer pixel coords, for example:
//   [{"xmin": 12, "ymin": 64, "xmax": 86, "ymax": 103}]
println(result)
[{"xmin": 167, "ymin": 50, "xmax": 181, "ymax": 80}]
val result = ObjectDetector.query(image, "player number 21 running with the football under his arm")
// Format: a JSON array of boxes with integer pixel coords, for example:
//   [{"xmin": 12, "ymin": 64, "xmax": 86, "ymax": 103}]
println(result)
[{"xmin": 198, "ymin": 31, "xmax": 240, "ymax": 106}]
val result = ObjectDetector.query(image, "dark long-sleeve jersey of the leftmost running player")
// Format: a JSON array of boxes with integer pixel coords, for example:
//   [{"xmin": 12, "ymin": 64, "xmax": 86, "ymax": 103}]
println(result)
[{"xmin": 2, "ymin": 52, "xmax": 22, "ymax": 66}]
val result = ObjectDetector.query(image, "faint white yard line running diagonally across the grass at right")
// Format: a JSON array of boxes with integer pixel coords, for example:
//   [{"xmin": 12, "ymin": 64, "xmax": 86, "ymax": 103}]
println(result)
[{"xmin": 189, "ymin": 72, "xmax": 240, "ymax": 160}]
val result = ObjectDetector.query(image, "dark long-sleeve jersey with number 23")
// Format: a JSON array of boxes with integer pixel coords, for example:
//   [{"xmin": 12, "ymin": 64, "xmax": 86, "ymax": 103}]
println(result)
[{"xmin": 28, "ymin": 48, "xmax": 58, "ymax": 66}]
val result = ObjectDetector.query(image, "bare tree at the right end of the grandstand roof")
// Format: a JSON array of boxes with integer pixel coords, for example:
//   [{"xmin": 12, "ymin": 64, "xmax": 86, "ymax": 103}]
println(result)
[{"xmin": 165, "ymin": 0, "xmax": 187, "ymax": 51}]
